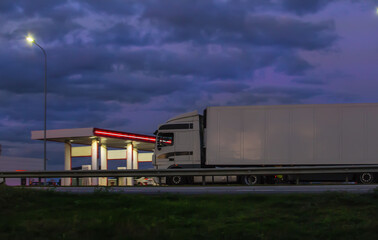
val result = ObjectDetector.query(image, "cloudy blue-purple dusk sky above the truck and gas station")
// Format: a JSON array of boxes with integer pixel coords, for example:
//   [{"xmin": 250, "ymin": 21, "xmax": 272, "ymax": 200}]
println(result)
[{"xmin": 0, "ymin": 0, "xmax": 378, "ymax": 170}]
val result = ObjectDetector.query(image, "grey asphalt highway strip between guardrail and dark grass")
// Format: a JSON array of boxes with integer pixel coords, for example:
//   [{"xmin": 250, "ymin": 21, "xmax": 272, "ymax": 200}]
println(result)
[{"xmin": 37, "ymin": 184, "xmax": 378, "ymax": 195}]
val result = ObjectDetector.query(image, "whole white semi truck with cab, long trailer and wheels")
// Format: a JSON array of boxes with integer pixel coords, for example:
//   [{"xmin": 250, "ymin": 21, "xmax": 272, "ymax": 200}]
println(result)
[{"xmin": 153, "ymin": 103, "xmax": 378, "ymax": 185}]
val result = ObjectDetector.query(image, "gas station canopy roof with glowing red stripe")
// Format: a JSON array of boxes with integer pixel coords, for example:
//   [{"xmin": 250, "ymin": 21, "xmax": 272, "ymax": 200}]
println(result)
[{"xmin": 31, "ymin": 128, "xmax": 155, "ymax": 151}]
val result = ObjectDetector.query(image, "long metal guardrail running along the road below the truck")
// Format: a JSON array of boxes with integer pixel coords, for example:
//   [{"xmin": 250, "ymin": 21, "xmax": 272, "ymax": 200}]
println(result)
[{"xmin": 0, "ymin": 165, "xmax": 378, "ymax": 178}]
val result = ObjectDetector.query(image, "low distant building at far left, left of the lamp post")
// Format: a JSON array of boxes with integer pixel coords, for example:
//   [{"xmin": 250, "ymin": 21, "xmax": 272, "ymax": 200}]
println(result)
[{"xmin": 0, "ymin": 155, "xmax": 43, "ymax": 186}]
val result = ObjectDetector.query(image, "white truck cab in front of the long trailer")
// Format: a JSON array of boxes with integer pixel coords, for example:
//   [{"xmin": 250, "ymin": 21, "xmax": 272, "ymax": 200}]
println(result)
[{"xmin": 153, "ymin": 111, "xmax": 201, "ymax": 169}]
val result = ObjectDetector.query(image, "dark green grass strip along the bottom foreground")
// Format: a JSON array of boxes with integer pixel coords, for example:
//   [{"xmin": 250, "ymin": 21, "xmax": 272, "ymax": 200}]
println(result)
[{"xmin": 0, "ymin": 186, "xmax": 378, "ymax": 240}]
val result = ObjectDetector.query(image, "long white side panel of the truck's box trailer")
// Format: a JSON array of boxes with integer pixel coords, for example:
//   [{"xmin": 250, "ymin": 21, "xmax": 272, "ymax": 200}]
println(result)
[{"xmin": 206, "ymin": 104, "xmax": 378, "ymax": 166}]
